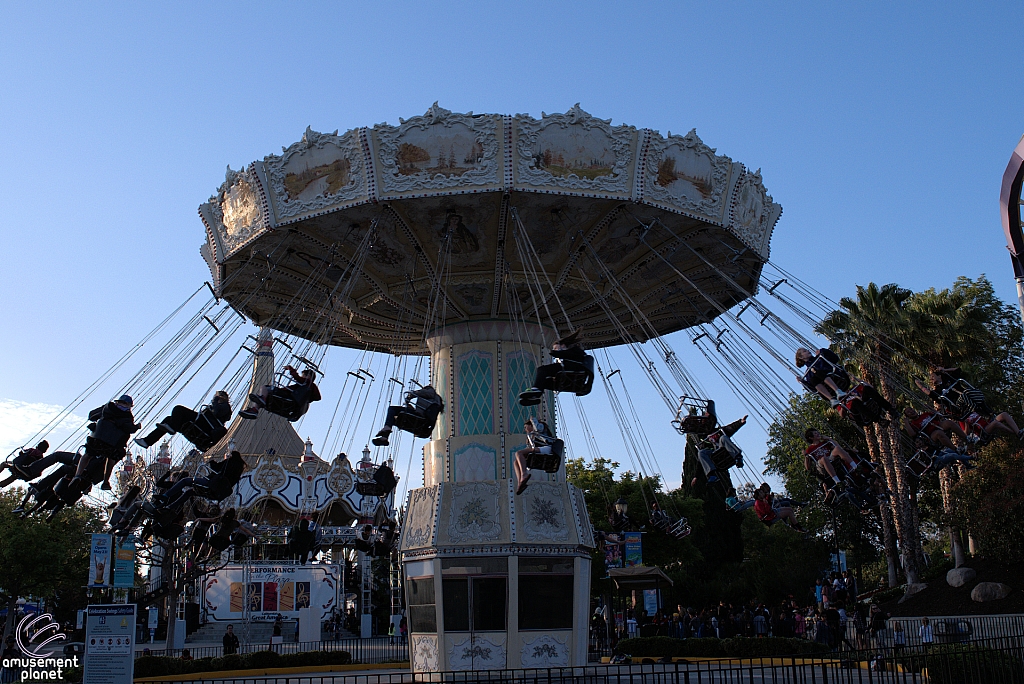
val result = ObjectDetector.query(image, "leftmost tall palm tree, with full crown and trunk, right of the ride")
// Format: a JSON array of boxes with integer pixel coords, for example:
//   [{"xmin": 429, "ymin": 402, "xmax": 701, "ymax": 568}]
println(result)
[{"xmin": 818, "ymin": 283, "xmax": 924, "ymax": 584}]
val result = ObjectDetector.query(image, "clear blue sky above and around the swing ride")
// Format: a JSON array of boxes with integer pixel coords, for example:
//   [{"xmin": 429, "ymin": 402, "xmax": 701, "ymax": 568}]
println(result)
[{"xmin": 0, "ymin": 2, "xmax": 1024, "ymax": 499}]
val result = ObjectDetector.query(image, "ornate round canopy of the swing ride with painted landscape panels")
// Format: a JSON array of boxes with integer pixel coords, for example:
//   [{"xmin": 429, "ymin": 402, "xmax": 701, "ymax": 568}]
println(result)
[{"xmin": 200, "ymin": 103, "xmax": 782, "ymax": 353}]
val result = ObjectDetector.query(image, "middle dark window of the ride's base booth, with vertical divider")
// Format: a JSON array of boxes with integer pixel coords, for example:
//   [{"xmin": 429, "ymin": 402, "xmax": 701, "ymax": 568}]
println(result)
[{"xmin": 441, "ymin": 558, "xmax": 508, "ymax": 632}]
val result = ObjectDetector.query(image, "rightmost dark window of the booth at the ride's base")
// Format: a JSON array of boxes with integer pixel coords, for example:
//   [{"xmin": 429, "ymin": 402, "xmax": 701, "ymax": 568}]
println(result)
[{"xmin": 519, "ymin": 558, "xmax": 574, "ymax": 630}]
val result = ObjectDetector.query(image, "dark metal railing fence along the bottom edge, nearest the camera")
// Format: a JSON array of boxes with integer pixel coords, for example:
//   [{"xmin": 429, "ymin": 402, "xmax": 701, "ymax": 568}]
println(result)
[{"xmin": 140, "ymin": 640, "xmax": 1024, "ymax": 684}]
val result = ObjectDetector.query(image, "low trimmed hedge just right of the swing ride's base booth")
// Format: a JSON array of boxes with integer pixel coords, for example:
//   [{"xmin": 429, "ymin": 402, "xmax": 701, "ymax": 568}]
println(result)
[{"xmin": 615, "ymin": 637, "xmax": 828, "ymax": 657}]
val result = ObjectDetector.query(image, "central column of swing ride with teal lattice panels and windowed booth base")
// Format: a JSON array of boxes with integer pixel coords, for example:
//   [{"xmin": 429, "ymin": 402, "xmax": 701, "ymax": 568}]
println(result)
[{"xmin": 400, "ymin": 322, "xmax": 594, "ymax": 672}]
